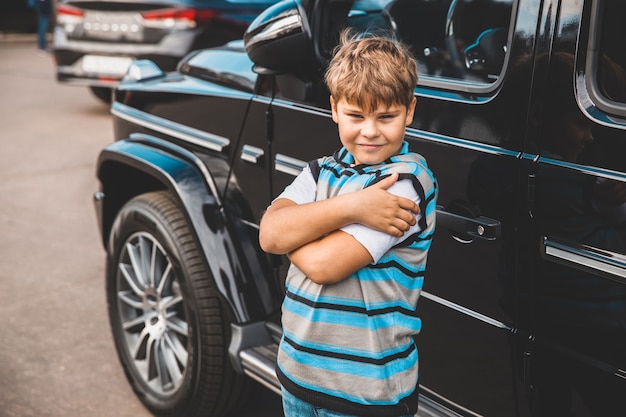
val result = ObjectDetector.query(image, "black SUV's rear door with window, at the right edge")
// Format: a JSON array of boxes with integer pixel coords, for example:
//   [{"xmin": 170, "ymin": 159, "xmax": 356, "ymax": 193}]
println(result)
[{"xmin": 525, "ymin": 1, "xmax": 626, "ymax": 416}]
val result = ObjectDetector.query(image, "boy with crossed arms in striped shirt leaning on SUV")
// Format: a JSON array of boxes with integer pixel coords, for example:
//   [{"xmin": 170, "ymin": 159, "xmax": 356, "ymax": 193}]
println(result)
[{"xmin": 259, "ymin": 33, "xmax": 437, "ymax": 417}]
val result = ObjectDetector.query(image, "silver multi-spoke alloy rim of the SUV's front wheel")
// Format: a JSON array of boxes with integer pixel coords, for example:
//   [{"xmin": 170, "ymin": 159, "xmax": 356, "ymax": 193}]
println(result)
[{"xmin": 117, "ymin": 232, "xmax": 189, "ymax": 396}]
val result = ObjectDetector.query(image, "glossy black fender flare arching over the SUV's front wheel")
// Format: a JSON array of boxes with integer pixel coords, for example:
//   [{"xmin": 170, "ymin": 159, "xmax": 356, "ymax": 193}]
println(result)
[{"xmin": 94, "ymin": 134, "xmax": 280, "ymax": 323}]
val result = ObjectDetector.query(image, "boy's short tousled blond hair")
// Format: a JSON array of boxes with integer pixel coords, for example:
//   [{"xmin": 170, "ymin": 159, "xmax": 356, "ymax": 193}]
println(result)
[{"xmin": 325, "ymin": 31, "xmax": 417, "ymax": 110}]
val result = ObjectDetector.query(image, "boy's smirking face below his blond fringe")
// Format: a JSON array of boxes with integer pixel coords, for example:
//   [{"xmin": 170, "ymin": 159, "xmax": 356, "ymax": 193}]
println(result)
[{"xmin": 330, "ymin": 97, "xmax": 415, "ymax": 165}]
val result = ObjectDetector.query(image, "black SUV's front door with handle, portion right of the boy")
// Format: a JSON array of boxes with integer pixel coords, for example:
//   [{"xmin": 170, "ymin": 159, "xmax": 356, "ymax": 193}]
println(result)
[{"xmin": 395, "ymin": 1, "xmax": 537, "ymax": 416}]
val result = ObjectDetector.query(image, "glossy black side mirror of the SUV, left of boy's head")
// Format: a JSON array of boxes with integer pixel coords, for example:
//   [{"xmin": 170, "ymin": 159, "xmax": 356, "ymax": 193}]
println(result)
[{"xmin": 243, "ymin": 0, "xmax": 310, "ymax": 73}]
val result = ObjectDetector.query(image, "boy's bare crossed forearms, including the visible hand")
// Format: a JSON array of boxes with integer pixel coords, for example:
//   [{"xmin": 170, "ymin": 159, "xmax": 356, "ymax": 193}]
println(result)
[{"xmin": 259, "ymin": 174, "xmax": 419, "ymax": 284}]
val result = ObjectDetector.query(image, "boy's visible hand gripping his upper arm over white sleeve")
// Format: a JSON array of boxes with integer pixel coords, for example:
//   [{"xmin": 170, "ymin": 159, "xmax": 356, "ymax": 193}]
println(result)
[{"xmin": 352, "ymin": 173, "xmax": 420, "ymax": 236}]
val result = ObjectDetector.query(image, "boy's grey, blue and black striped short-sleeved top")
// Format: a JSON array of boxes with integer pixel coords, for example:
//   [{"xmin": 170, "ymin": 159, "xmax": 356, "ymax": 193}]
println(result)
[{"xmin": 276, "ymin": 142, "xmax": 437, "ymax": 417}]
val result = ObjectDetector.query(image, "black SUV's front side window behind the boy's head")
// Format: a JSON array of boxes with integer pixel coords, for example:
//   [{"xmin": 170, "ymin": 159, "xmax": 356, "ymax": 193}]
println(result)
[{"xmin": 320, "ymin": 0, "xmax": 513, "ymax": 85}]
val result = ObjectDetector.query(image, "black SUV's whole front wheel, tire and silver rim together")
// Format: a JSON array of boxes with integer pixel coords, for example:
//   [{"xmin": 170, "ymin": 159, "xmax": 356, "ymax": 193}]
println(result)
[{"xmin": 106, "ymin": 192, "xmax": 247, "ymax": 417}]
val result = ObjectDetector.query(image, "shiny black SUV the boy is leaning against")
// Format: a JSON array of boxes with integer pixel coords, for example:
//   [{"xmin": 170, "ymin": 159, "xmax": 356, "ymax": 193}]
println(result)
[{"xmin": 95, "ymin": 0, "xmax": 626, "ymax": 417}]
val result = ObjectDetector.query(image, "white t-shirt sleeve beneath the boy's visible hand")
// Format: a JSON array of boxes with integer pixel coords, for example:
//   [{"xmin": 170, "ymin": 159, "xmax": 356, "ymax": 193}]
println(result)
[{"xmin": 341, "ymin": 180, "xmax": 422, "ymax": 263}]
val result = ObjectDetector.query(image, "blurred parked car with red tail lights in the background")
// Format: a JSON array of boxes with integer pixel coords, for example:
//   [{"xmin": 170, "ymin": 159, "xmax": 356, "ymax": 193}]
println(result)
[{"xmin": 53, "ymin": 0, "xmax": 275, "ymax": 102}]
